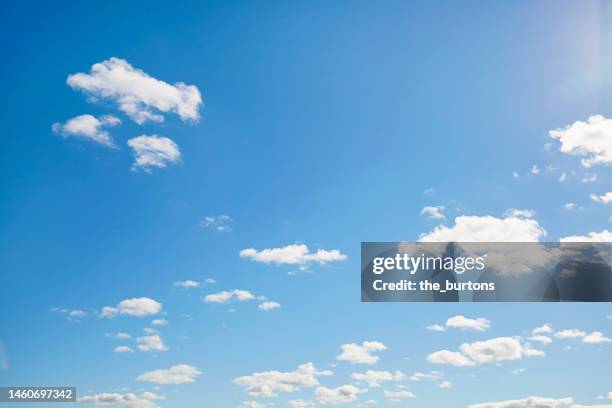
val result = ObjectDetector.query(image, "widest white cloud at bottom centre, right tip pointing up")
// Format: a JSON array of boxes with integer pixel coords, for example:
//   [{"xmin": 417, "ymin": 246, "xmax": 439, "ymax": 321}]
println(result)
[{"xmin": 234, "ymin": 363, "xmax": 333, "ymax": 397}]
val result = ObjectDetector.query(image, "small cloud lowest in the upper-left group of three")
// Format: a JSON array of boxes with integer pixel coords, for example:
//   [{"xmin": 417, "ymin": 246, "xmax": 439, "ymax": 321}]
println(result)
[{"xmin": 127, "ymin": 135, "xmax": 181, "ymax": 172}]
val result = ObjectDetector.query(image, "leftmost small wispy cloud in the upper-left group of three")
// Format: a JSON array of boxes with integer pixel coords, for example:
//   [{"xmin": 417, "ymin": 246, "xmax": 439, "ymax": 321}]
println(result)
[{"xmin": 51, "ymin": 114, "xmax": 121, "ymax": 148}]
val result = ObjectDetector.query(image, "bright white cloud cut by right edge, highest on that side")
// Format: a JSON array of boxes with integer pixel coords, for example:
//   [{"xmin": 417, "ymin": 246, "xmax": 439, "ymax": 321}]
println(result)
[{"xmin": 548, "ymin": 115, "xmax": 612, "ymax": 167}]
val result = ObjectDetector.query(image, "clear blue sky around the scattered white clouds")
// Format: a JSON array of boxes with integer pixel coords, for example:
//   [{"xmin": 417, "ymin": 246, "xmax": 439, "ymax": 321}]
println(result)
[{"xmin": 0, "ymin": 1, "xmax": 612, "ymax": 408}]
